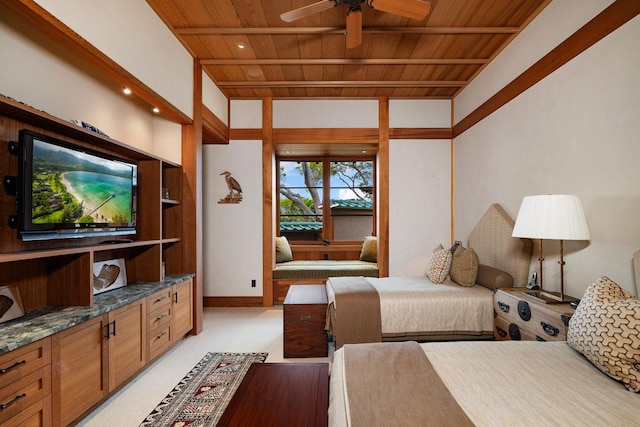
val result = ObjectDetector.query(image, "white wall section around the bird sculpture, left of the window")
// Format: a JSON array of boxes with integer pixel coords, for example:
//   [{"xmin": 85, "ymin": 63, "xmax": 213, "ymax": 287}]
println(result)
[{"xmin": 202, "ymin": 141, "xmax": 262, "ymax": 296}]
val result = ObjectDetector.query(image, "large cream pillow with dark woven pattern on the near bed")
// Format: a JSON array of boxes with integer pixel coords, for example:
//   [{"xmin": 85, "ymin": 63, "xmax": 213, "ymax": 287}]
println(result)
[{"xmin": 567, "ymin": 277, "xmax": 640, "ymax": 393}]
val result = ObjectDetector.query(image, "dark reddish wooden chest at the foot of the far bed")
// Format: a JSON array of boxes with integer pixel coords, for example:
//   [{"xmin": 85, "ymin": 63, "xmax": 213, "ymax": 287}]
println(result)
[{"xmin": 283, "ymin": 285, "xmax": 329, "ymax": 357}]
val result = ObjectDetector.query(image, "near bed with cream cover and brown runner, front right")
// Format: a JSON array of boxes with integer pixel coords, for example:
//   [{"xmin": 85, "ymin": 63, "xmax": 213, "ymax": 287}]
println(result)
[{"xmin": 329, "ymin": 341, "xmax": 640, "ymax": 427}]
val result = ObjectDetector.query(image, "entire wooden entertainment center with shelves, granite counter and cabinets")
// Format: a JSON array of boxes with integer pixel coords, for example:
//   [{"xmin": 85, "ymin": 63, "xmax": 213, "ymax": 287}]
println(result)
[{"xmin": 0, "ymin": 97, "xmax": 195, "ymax": 426}]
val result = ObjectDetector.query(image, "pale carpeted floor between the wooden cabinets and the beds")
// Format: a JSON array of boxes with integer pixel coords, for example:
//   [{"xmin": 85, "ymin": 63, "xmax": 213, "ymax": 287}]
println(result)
[{"xmin": 79, "ymin": 306, "xmax": 330, "ymax": 427}]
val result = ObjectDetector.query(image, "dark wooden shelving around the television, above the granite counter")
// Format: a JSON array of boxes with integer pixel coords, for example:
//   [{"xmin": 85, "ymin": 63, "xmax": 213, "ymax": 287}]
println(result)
[{"xmin": 0, "ymin": 97, "xmax": 184, "ymax": 312}]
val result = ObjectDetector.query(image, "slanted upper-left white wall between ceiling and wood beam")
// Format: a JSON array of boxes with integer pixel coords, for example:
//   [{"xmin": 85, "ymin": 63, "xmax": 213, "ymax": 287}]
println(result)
[{"xmin": 36, "ymin": 0, "xmax": 193, "ymax": 117}]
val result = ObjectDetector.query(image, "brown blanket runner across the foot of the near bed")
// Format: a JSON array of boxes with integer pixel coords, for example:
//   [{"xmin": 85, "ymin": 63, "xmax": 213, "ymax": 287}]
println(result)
[{"xmin": 343, "ymin": 342, "xmax": 473, "ymax": 427}]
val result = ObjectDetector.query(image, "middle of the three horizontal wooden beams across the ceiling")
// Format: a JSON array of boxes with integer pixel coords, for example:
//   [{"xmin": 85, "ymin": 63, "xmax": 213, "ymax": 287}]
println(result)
[{"xmin": 200, "ymin": 58, "xmax": 488, "ymax": 66}]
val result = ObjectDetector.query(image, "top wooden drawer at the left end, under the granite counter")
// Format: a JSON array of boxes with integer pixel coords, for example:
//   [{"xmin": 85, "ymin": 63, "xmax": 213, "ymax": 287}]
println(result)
[{"xmin": 0, "ymin": 338, "xmax": 51, "ymax": 388}]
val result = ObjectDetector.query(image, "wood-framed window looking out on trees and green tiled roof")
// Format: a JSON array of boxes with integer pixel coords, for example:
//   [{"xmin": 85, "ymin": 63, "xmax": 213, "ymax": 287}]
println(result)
[{"xmin": 278, "ymin": 157, "xmax": 375, "ymax": 242}]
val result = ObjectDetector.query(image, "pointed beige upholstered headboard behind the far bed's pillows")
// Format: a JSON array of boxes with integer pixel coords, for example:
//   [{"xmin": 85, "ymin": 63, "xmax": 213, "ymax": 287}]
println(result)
[{"xmin": 469, "ymin": 203, "xmax": 533, "ymax": 287}]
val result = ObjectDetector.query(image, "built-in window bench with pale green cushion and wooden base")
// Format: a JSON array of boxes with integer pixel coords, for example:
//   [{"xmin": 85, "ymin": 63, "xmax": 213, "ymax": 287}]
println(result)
[{"xmin": 273, "ymin": 260, "xmax": 378, "ymax": 302}]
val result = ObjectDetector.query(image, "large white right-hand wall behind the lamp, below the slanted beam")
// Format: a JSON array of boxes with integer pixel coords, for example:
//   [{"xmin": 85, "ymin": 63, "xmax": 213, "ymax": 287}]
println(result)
[{"xmin": 455, "ymin": 11, "xmax": 640, "ymax": 297}]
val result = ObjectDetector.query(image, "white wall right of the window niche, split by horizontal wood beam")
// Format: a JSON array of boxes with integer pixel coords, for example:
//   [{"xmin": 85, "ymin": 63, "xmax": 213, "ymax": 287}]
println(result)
[{"xmin": 389, "ymin": 99, "xmax": 451, "ymax": 276}]
